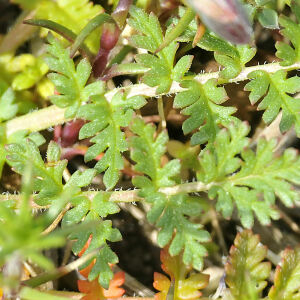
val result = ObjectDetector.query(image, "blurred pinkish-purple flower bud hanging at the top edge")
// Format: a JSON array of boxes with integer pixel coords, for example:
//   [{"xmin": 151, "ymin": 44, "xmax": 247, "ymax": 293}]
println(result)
[{"xmin": 187, "ymin": 0, "xmax": 253, "ymax": 44}]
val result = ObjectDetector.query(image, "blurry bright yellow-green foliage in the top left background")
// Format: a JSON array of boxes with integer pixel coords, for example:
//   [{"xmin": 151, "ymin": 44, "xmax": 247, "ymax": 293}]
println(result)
[{"xmin": 13, "ymin": 0, "xmax": 103, "ymax": 53}]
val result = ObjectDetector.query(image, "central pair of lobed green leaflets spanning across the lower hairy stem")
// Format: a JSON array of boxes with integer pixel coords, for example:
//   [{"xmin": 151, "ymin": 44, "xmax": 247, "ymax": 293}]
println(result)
[{"xmin": 131, "ymin": 118, "xmax": 210, "ymax": 270}]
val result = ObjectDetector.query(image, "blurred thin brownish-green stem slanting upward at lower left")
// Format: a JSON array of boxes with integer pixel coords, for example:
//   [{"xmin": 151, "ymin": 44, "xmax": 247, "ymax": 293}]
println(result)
[{"xmin": 22, "ymin": 246, "xmax": 104, "ymax": 288}]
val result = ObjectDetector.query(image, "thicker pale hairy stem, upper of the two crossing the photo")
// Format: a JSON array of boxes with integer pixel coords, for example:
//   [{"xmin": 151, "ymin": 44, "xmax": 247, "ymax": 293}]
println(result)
[{"xmin": 6, "ymin": 62, "xmax": 300, "ymax": 136}]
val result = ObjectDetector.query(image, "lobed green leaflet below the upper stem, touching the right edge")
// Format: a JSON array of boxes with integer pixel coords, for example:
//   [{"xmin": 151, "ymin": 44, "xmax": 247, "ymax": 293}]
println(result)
[{"xmin": 245, "ymin": 70, "xmax": 300, "ymax": 135}]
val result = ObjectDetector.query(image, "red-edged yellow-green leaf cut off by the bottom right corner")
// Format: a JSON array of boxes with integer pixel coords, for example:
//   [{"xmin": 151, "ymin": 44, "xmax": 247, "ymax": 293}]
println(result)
[{"xmin": 268, "ymin": 247, "xmax": 300, "ymax": 300}]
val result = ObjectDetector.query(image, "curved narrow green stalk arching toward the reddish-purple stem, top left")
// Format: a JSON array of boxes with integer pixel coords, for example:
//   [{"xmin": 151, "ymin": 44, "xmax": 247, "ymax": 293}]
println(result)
[{"xmin": 70, "ymin": 13, "xmax": 115, "ymax": 57}]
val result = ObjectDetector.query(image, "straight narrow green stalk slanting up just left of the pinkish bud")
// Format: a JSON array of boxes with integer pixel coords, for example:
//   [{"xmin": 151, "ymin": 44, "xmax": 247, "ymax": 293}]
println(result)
[{"xmin": 155, "ymin": 8, "xmax": 195, "ymax": 53}]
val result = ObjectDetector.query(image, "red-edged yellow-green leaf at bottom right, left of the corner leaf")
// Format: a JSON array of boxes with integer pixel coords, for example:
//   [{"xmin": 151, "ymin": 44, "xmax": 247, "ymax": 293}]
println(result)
[{"xmin": 225, "ymin": 230, "xmax": 271, "ymax": 300}]
